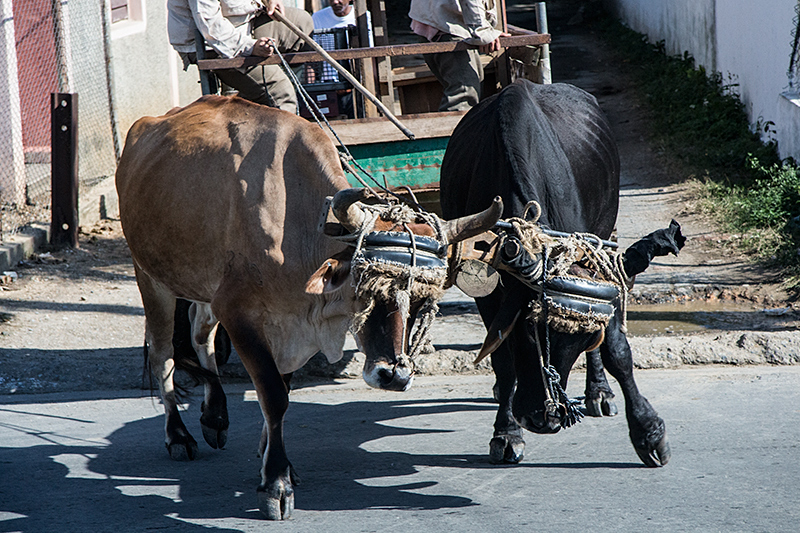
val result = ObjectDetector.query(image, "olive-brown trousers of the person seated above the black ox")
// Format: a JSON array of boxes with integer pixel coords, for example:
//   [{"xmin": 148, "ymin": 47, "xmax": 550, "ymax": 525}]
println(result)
[{"xmin": 423, "ymin": 34, "xmax": 483, "ymax": 111}]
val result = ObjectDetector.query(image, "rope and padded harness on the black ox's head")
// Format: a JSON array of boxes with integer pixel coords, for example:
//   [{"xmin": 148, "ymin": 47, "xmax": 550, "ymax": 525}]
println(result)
[{"xmin": 451, "ymin": 201, "xmax": 632, "ymax": 428}]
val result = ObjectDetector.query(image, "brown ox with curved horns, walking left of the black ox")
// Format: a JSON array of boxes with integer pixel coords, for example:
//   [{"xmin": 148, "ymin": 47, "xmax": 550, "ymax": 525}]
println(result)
[{"xmin": 116, "ymin": 93, "xmax": 502, "ymax": 519}]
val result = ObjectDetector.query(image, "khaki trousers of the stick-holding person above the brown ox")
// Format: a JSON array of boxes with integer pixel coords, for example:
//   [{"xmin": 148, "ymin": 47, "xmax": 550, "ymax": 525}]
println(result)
[{"xmin": 214, "ymin": 7, "xmax": 314, "ymax": 113}]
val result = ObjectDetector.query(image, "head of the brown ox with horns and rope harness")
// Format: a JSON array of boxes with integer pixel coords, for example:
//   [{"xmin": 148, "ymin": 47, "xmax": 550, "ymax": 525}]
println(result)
[{"xmin": 319, "ymin": 189, "xmax": 503, "ymax": 391}]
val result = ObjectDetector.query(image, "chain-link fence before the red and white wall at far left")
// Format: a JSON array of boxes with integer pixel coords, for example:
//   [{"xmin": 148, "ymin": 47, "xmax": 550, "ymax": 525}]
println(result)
[{"xmin": 0, "ymin": 0, "xmax": 119, "ymax": 238}]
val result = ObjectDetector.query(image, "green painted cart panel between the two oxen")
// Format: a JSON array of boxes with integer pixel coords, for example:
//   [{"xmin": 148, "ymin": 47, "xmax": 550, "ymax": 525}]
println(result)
[{"xmin": 347, "ymin": 137, "xmax": 450, "ymax": 188}]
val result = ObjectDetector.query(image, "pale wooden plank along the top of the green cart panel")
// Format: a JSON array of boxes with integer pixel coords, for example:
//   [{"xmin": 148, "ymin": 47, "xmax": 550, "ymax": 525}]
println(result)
[{"xmin": 325, "ymin": 111, "xmax": 467, "ymax": 145}]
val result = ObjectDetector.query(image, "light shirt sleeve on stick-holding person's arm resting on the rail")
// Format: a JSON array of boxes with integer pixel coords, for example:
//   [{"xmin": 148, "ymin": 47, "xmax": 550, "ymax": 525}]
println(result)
[{"xmin": 189, "ymin": 0, "xmax": 256, "ymax": 58}]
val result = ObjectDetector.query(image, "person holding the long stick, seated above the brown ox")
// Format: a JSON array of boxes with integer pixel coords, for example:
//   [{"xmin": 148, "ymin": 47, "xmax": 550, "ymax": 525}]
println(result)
[{"xmin": 167, "ymin": 0, "xmax": 313, "ymax": 113}]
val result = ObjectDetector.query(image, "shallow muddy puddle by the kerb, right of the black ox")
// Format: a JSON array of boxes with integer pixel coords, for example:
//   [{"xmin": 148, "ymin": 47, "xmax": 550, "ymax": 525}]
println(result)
[{"xmin": 628, "ymin": 301, "xmax": 768, "ymax": 336}]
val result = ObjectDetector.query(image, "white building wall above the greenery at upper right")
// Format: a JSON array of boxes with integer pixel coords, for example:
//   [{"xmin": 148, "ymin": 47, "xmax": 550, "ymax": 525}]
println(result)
[{"xmin": 605, "ymin": 0, "xmax": 800, "ymax": 161}]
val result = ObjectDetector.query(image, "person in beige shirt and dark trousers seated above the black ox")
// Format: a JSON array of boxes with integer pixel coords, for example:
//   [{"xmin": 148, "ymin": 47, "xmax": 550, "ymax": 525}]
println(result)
[{"xmin": 408, "ymin": 0, "xmax": 509, "ymax": 111}]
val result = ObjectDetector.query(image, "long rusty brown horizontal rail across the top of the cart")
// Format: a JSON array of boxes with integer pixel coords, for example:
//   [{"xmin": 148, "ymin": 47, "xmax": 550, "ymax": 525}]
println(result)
[{"xmin": 198, "ymin": 30, "xmax": 550, "ymax": 70}]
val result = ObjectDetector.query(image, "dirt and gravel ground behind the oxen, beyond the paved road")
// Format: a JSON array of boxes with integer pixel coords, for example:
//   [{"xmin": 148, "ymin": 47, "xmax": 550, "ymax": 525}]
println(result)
[{"xmin": 0, "ymin": 0, "xmax": 800, "ymax": 394}]
